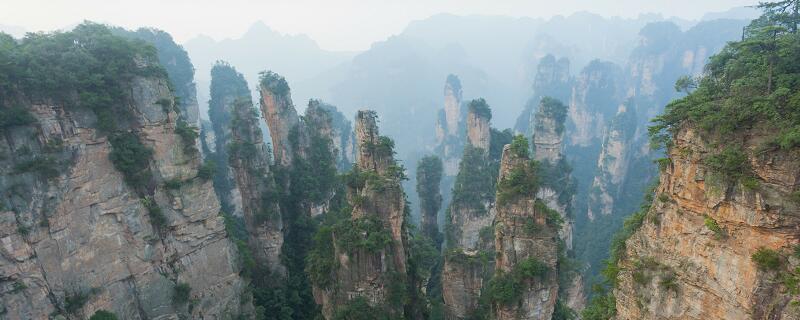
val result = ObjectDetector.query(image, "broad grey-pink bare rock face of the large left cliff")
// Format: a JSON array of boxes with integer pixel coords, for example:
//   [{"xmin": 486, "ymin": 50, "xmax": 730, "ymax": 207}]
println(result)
[{"xmin": 0, "ymin": 77, "xmax": 248, "ymax": 319}]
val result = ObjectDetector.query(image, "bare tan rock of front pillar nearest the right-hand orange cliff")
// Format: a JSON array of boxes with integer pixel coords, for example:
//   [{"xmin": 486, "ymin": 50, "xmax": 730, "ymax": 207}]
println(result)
[{"xmin": 493, "ymin": 145, "xmax": 558, "ymax": 319}]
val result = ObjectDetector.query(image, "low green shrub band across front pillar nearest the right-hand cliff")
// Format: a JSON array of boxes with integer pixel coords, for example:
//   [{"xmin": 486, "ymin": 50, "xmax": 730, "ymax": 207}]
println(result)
[{"xmin": 486, "ymin": 257, "xmax": 549, "ymax": 306}]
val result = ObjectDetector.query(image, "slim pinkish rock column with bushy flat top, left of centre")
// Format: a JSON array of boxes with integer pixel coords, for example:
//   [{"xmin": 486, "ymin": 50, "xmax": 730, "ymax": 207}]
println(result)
[{"xmin": 259, "ymin": 71, "xmax": 300, "ymax": 166}]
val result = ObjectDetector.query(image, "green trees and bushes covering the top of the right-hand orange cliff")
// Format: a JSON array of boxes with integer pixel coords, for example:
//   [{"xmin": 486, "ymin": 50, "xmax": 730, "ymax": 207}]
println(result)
[{"xmin": 650, "ymin": 5, "xmax": 800, "ymax": 149}]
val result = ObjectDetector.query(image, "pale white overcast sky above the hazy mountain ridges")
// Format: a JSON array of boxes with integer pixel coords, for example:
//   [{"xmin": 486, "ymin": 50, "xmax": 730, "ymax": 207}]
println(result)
[{"xmin": 0, "ymin": 0, "xmax": 758, "ymax": 50}]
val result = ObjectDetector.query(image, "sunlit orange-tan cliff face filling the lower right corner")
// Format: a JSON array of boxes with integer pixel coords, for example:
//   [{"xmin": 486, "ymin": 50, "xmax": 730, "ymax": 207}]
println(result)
[{"xmin": 614, "ymin": 126, "xmax": 800, "ymax": 319}]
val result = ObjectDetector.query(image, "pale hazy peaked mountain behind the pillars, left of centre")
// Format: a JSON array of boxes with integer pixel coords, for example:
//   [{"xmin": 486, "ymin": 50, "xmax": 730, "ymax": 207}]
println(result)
[{"xmin": 183, "ymin": 21, "xmax": 353, "ymax": 117}]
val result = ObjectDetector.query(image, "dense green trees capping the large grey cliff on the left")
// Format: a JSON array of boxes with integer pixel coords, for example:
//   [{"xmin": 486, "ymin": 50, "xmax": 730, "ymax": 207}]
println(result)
[{"xmin": 0, "ymin": 22, "xmax": 166, "ymax": 132}]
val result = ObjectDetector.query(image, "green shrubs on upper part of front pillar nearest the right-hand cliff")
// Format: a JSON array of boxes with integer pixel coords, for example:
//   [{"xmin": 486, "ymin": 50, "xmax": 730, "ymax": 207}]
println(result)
[{"xmin": 497, "ymin": 161, "xmax": 539, "ymax": 205}]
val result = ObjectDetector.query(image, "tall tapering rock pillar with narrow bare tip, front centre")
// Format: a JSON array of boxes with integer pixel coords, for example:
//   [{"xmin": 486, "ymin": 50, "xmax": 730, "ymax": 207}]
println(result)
[{"xmin": 314, "ymin": 110, "xmax": 407, "ymax": 319}]
